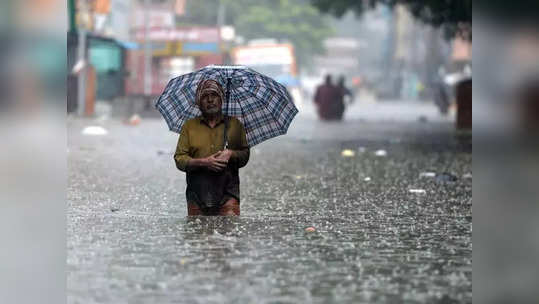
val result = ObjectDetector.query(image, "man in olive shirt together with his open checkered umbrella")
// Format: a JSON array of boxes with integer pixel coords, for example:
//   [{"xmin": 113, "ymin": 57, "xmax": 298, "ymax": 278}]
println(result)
[{"xmin": 155, "ymin": 65, "xmax": 298, "ymax": 215}]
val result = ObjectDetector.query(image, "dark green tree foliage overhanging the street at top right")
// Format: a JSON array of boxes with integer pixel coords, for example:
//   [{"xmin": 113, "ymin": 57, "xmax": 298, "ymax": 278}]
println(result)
[{"xmin": 311, "ymin": 0, "xmax": 472, "ymax": 39}]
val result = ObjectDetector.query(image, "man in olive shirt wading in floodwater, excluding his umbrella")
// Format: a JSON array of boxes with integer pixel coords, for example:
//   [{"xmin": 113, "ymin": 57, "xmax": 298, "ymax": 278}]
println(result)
[{"xmin": 174, "ymin": 80, "xmax": 249, "ymax": 215}]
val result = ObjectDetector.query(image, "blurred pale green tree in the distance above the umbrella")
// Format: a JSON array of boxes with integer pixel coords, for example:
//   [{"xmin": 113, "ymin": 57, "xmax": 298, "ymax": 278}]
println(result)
[{"xmin": 177, "ymin": 0, "xmax": 333, "ymax": 67}]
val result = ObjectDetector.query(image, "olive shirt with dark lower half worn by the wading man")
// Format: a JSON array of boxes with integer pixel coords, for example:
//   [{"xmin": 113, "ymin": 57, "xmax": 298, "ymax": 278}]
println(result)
[{"xmin": 174, "ymin": 117, "xmax": 249, "ymax": 207}]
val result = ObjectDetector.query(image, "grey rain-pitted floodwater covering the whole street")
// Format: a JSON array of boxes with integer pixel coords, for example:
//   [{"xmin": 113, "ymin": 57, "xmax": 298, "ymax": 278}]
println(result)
[{"xmin": 67, "ymin": 105, "xmax": 472, "ymax": 303}]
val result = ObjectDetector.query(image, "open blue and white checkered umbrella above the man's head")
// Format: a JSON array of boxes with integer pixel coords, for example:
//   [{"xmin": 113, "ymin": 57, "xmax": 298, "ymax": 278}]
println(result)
[{"xmin": 155, "ymin": 65, "xmax": 298, "ymax": 147}]
